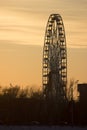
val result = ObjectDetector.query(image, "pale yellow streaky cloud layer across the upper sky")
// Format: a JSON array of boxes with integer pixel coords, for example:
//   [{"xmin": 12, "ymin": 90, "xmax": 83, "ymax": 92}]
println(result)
[{"xmin": 0, "ymin": 0, "xmax": 87, "ymax": 45}]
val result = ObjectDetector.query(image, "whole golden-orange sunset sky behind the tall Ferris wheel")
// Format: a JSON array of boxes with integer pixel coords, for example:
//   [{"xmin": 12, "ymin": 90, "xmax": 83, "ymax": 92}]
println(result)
[{"xmin": 0, "ymin": 0, "xmax": 87, "ymax": 86}]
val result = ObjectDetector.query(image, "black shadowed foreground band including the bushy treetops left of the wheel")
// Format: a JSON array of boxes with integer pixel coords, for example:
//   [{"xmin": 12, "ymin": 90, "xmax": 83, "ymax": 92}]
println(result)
[{"xmin": 0, "ymin": 86, "xmax": 87, "ymax": 126}]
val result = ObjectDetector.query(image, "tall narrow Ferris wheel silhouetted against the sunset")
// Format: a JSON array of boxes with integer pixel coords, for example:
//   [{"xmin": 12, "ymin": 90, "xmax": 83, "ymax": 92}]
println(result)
[{"xmin": 42, "ymin": 14, "xmax": 67, "ymax": 100}]
